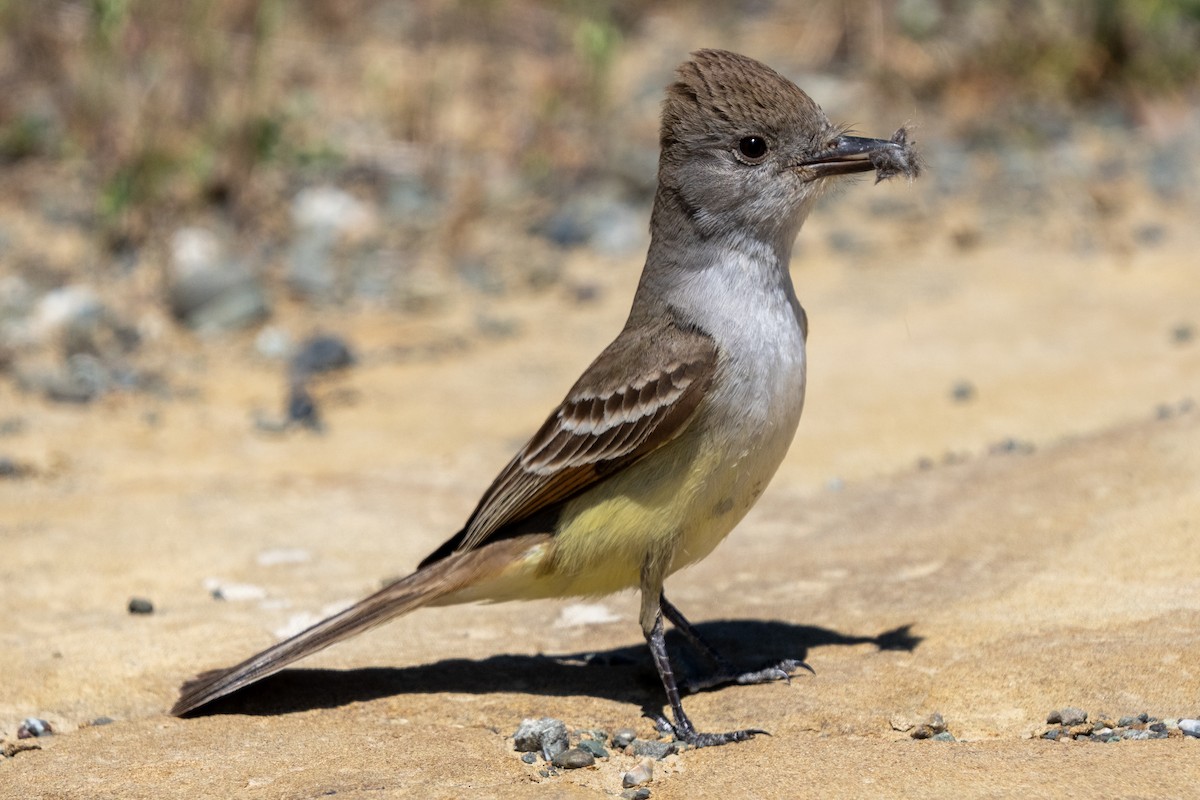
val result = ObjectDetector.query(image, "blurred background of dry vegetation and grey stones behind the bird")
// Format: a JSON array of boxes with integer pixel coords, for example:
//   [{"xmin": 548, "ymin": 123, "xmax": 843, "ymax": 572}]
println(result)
[{"xmin": 0, "ymin": 0, "xmax": 1200, "ymax": 471}]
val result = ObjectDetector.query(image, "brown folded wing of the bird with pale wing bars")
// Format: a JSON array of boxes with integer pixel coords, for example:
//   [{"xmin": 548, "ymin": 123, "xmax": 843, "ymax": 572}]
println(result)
[{"xmin": 426, "ymin": 309, "xmax": 718, "ymax": 563}]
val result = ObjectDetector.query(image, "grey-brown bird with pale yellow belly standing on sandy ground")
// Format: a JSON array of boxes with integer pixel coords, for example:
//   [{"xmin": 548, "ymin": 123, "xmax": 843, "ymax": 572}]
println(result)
[{"xmin": 170, "ymin": 49, "xmax": 920, "ymax": 747}]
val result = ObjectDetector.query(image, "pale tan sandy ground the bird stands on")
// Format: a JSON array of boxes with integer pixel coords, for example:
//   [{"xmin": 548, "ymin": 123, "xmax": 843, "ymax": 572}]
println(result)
[{"xmin": 0, "ymin": 167, "xmax": 1200, "ymax": 799}]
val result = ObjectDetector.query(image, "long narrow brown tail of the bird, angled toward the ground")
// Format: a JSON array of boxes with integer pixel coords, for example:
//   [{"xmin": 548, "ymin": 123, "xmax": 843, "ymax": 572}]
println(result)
[{"xmin": 170, "ymin": 537, "xmax": 532, "ymax": 716}]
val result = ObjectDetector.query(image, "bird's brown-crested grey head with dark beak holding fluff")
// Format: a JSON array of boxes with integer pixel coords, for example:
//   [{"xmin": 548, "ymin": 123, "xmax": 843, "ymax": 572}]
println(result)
[{"xmin": 659, "ymin": 50, "xmax": 919, "ymax": 246}]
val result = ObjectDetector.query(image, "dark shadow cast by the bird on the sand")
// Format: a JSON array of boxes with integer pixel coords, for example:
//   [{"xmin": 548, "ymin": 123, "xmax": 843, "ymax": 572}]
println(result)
[{"xmin": 187, "ymin": 620, "xmax": 922, "ymax": 716}]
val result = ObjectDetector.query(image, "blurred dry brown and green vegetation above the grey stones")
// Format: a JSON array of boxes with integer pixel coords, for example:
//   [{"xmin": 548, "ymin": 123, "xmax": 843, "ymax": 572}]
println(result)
[{"xmin": 0, "ymin": 0, "xmax": 1200, "ymax": 252}]
